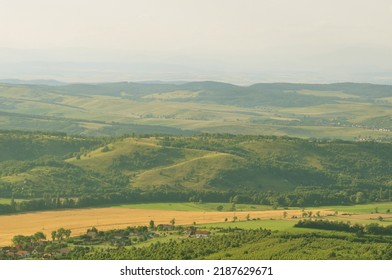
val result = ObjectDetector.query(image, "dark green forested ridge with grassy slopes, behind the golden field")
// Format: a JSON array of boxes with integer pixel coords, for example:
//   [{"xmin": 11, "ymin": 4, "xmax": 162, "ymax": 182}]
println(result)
[{"xmin": 0, "ymin": 131, "xmax": 392, "ymax": 213}]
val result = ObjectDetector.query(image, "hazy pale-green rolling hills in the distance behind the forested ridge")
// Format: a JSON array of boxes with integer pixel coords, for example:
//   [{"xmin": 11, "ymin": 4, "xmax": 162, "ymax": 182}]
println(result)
[{"xmin": 0, "ymin": 81, "xmax": 392, "ymax": 141}]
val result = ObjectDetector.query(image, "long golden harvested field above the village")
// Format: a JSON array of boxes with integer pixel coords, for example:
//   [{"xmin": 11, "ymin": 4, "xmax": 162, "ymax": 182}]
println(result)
[{"xmin": 0, "ymin": 207, "xmax": 333, "ymax": 246}]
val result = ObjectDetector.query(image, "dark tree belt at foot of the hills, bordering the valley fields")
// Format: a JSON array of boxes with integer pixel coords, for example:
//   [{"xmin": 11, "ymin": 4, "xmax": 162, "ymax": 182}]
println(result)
[{"xmin": 0, "ymin": 185, "xmax": 389, "ymax": 214}]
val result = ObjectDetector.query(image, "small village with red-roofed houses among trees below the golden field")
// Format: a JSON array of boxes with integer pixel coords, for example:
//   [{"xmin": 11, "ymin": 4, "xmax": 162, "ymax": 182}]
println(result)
[{"xmin": 0, "ymin": 222, "xmax": 212, "ymax": 260}]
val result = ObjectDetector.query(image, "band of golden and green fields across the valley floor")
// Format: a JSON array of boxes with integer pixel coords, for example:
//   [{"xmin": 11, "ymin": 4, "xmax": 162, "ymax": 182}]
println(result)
[{"xmin": 0, "ymin": 203, "xmax": 392, "ymax": 246}]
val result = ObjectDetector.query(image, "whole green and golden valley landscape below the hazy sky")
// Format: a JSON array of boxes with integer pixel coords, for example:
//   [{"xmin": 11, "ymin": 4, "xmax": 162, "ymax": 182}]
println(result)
[{"xmin": 0, "ymin": 82, "xmax": 392, "ymax": 259}]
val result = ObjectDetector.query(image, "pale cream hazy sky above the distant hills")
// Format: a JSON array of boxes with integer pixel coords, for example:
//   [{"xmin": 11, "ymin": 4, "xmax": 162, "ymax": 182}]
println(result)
[{"xmin": 0, "ymin": 0, "xmax": 392, "ymax": 84}]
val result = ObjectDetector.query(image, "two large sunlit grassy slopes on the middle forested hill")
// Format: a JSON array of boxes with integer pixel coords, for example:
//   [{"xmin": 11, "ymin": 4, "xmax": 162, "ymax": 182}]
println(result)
[{"xmin": 68, "ymin": 138, "xmax": 243, "ymax": 188}]
